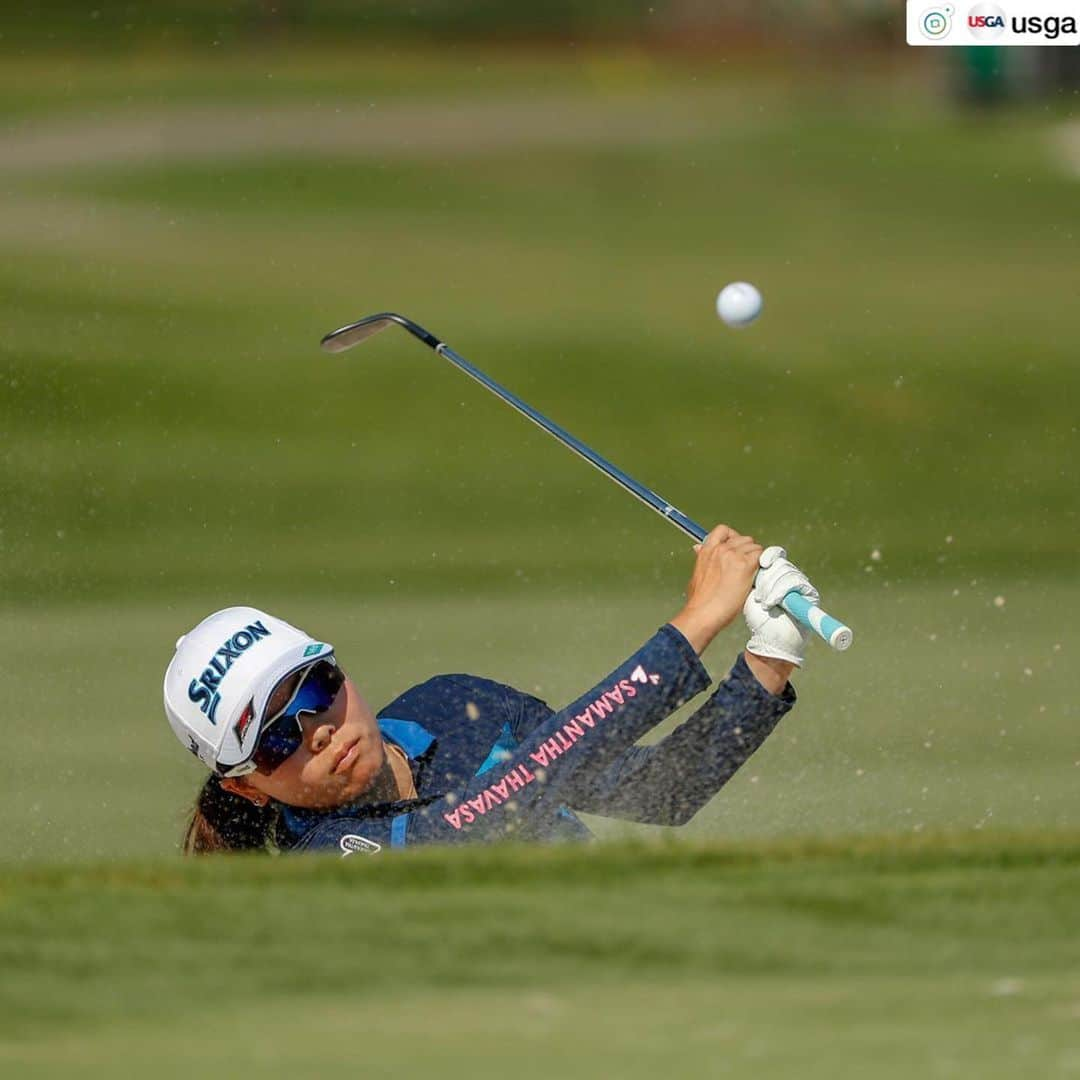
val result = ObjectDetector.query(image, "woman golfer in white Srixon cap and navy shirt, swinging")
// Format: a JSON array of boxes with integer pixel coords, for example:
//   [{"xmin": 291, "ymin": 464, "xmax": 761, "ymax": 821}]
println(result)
[{"xmin": 164, "ymin": 525, "xmax": 818, "ymax": 854}]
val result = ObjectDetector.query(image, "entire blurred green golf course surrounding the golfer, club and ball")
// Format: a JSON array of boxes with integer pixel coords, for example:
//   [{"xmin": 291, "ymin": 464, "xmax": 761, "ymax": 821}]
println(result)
[{"xmin": 0, "ymin": 0, "xmax": 1080, "ymax": 1080}]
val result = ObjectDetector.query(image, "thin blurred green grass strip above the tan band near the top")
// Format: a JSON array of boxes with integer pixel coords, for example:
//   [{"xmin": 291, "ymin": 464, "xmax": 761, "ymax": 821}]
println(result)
[{"xmin": 0, "ymin": 46, "xmax": 665, "ymax": 120}]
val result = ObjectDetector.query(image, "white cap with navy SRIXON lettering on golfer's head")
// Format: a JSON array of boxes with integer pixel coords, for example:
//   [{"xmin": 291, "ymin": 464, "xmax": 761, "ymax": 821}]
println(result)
[{"xmin": 165, "ymin": 607, "xmax": 334, "ymax": 771}]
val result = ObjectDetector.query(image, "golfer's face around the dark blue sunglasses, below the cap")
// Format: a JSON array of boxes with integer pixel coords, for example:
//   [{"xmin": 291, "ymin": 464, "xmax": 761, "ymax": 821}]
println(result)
[{"xmin": 247, "ymin": 675, "xmax": 386, "ymax": 809}]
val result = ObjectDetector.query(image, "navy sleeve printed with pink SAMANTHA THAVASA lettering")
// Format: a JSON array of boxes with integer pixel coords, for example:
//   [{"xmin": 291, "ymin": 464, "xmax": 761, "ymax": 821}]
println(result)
[{"xmin": 408, "ymin": 625, "xmax": 708, "ymax": 843}]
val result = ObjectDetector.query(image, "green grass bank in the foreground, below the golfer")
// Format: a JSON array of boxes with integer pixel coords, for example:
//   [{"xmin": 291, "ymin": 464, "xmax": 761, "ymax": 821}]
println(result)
[{"xmin": 0, "ymin": 834, "xmax": 1080, "ymax": 1077}]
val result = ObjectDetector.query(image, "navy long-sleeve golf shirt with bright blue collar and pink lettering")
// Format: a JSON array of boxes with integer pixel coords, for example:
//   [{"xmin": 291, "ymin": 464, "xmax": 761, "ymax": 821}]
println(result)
[{"xmin": 278, "ymin": 625, "xmax": 795, "ymax": 854}]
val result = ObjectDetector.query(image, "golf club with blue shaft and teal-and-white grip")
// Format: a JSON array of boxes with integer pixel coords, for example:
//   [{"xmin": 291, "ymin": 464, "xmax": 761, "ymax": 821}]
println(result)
[{"xmin": 321, "ymin": 311, "xmax": 852, "ymax": 651}]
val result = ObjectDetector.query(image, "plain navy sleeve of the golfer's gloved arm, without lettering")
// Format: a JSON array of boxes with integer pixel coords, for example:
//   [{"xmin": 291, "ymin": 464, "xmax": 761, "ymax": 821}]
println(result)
[{"xmin": 566, "ymin": 656, "xmax": 795, "ymax": 825}]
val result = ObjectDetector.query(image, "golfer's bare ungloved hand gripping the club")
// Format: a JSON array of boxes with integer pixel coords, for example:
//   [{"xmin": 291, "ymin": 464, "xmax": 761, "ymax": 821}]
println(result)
[{"xmin": 671, "ymin": 525, "xmax": 762, "ymax": 652}]
